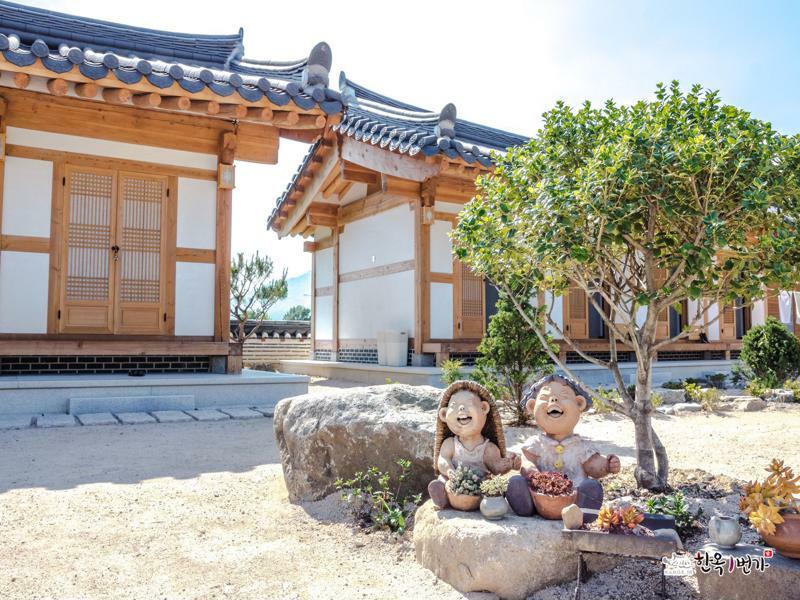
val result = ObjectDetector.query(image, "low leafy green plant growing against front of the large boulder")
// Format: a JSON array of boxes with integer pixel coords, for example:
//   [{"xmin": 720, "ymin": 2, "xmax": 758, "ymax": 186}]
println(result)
[{"xmin": 336, "ymin": 459, "xmax": 422, "ymax": 535}]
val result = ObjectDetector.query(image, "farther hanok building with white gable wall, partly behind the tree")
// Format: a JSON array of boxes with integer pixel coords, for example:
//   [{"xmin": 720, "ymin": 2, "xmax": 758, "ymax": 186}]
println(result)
[{"xmin": 270, "ymin": 77, "xmax": 798, "ymax": 379}]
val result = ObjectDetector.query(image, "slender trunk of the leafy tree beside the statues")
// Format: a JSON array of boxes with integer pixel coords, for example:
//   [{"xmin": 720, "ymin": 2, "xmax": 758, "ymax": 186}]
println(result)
[{"xmin": 631, "ymin": 352, "xmax": 667, "ymax": 491}]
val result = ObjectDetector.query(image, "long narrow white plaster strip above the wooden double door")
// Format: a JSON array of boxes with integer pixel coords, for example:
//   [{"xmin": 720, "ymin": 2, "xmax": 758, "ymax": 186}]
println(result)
[{"xmin": 6, "ymin": 127, "xmax": 217, "ymax": 171}]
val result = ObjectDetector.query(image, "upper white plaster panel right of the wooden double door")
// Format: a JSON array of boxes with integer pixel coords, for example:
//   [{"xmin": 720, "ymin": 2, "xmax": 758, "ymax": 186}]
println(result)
[{"xmin": 178, "ymin": 177, "xmax": 217, "ymax": 250}]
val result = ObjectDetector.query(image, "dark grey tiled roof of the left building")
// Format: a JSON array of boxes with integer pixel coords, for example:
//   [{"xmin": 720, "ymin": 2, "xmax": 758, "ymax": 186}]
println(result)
[{"xmin": 0, "ymin": 1, "xmax": 342, "ymax": 114}]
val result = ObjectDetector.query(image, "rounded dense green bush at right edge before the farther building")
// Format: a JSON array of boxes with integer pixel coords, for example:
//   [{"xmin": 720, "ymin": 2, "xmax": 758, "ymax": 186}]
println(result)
[{"xmin": 741, "ymin": 317, "xmax": 800, "ymax": 387}]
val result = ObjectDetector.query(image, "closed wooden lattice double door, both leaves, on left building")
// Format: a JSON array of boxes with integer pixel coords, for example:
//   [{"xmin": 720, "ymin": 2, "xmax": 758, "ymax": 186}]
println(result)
[{"xmin": 59, "ymin": 167, "xmax": 167, "ymax": 334}]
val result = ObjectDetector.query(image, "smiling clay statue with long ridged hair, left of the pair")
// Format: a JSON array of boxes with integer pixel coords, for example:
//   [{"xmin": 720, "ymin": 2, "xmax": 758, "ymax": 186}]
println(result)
[{"xmin": 428, "ymin": 381, "xmax": 522, "ymax": 508}]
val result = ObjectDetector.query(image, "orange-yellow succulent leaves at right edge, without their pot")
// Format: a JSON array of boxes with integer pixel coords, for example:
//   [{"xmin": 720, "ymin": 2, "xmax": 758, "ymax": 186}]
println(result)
[{"xmin": 739, "ymin": 458, "xmax": 800, "ymax": 537}]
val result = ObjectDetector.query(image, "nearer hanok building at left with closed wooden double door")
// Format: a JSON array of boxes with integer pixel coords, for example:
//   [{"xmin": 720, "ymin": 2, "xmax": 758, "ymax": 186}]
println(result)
[{"xmin": 0, "ymin": 2, "xmax": 332, "ymax": 404}]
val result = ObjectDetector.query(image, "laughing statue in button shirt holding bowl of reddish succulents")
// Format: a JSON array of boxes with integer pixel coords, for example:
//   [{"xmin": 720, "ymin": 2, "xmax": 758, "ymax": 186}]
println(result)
[{"xmin": 506, "ymin": 375, "xmax": 620, "ymax": 516}]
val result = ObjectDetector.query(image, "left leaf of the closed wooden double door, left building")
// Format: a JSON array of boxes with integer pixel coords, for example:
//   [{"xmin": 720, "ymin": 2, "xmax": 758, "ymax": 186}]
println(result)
[{"xmin": 59, "ymin": 167, "xmax": 115, "ymax": 333}]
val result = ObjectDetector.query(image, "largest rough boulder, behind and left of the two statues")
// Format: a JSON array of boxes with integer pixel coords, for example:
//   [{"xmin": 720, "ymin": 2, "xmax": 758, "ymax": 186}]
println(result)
[{"xmin": 274, "ymin": 384, "xmax": 441, "ymax": 502}]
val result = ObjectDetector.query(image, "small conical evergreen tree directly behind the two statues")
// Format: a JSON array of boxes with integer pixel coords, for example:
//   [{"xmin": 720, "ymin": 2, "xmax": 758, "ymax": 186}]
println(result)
[{"xmin": 472, "ymin": 297, "xmax": 558, "ymax": 425}]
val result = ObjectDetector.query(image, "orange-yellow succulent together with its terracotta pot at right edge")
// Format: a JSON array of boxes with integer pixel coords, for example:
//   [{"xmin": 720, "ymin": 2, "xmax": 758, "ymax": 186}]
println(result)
[{"xmin": 739, "ymin": 459, "xmax": 800, "ymax": 558}]
